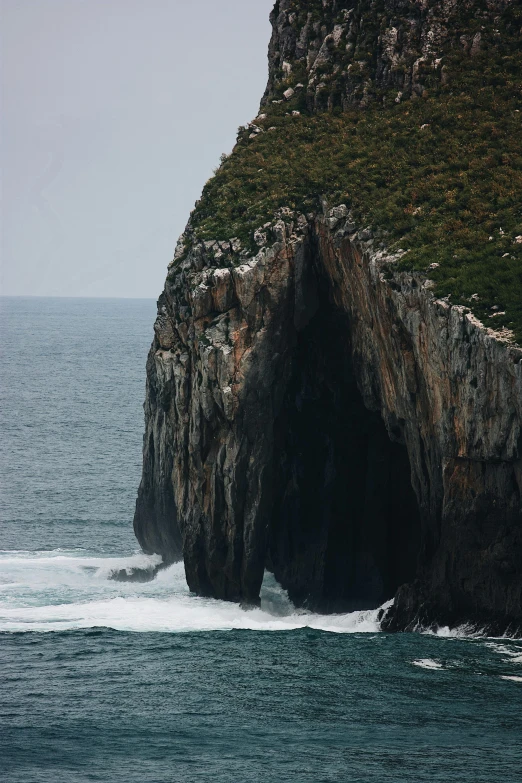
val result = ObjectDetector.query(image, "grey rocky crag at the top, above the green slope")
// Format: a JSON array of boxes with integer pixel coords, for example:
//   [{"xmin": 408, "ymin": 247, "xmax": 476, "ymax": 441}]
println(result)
[{"xmin": 262, "ymin": 0, "xmax": 518, "ymax": 111}]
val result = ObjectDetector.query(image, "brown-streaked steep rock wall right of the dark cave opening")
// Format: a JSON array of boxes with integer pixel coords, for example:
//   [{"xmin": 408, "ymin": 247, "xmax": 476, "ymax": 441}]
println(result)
[{"xmin": 320, "ymin": 217, "xmax": 522, "ymax": 631}]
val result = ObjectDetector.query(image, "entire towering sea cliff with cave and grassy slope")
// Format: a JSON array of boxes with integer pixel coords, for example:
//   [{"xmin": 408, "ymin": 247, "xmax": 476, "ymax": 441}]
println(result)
[{"xmin": 134, "ymin": 0, "xmax": 522, "ymax": 634}]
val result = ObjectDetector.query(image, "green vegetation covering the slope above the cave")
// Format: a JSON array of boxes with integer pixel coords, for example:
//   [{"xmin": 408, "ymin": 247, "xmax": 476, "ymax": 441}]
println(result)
[{"xmin": 186, "ymin": 17, "xmax": 522, "ymax": 342}]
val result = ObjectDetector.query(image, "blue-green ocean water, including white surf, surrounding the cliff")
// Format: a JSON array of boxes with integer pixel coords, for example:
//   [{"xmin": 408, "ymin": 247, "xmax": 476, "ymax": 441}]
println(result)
[{"xmin": 0, "ymin": 298, "xmax": 522, "ymax": 783}]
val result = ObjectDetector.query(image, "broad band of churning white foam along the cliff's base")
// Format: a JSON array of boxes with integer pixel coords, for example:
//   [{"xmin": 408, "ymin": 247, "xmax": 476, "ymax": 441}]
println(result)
[{"xmin": 0, "ymin": 550, "xmax": 379, "ymax": 633}]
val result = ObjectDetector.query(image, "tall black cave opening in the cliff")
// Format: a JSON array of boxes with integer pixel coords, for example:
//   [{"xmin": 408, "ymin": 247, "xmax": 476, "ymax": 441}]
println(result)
[{"xmin": 267, "ymin": 272, "xmax": 420, "ymax": 612}]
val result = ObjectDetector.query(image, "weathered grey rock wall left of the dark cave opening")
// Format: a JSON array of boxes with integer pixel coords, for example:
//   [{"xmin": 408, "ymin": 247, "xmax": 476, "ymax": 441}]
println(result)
[{"xmin": 135, "ymin": 223, "xmax": 305, "ymax": 602}]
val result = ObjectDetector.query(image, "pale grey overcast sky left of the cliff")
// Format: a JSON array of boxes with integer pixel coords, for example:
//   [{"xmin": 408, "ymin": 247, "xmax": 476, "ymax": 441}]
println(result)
[{"xmin": 0, "ymin": 0, "xmax": 273, "ymax": 298}]
